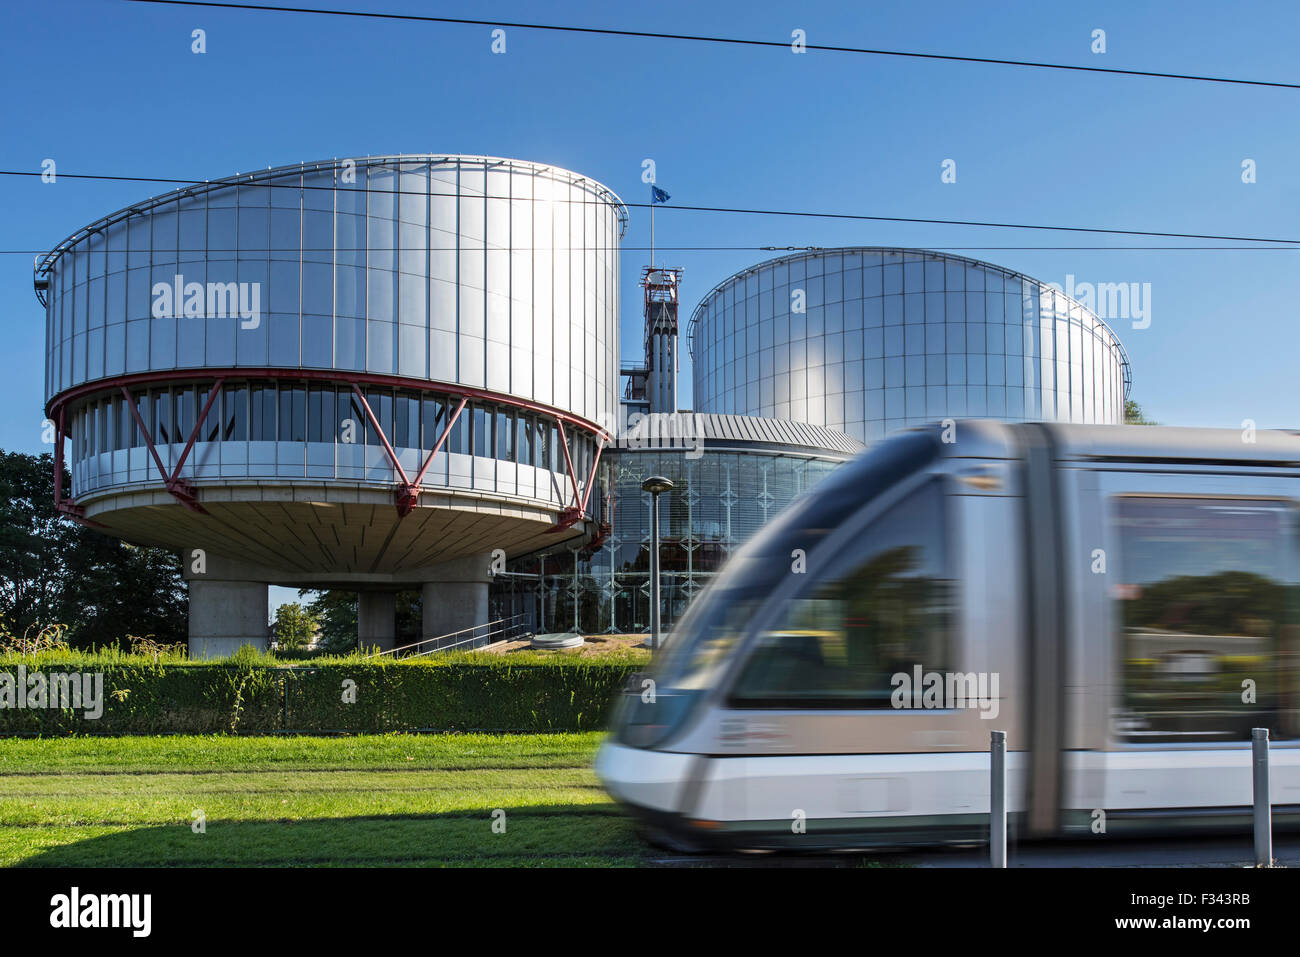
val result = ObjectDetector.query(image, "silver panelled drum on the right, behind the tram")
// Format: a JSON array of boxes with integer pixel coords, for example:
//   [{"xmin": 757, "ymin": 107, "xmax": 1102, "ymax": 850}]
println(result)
[{"xmin": 689, "ymin": 247, "xmax": 1128, "ymax": 442}]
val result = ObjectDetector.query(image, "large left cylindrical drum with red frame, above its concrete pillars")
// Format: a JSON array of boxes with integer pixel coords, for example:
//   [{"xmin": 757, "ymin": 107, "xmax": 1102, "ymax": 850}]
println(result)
[{"xmin": 36, "ymin": 155, "xmax": 627, "ymax": 573}]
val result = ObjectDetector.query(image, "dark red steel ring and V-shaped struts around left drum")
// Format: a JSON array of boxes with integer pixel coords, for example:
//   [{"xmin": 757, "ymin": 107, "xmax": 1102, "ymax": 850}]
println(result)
[{"xmin": 46, "ymin": 368, "xmax": 610, "ymax": 532}]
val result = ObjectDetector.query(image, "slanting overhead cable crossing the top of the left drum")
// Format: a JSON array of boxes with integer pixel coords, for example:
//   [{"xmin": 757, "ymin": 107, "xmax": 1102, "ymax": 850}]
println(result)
[{"xmin": 0, "ymin": 169, "xmax": 1300, "ymax": 248}]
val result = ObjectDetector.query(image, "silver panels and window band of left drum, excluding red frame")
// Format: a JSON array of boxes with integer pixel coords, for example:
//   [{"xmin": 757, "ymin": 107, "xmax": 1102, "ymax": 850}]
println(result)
[{"xmin": 39, "ymin": 156, "xmax": 627, "ymax": 512}]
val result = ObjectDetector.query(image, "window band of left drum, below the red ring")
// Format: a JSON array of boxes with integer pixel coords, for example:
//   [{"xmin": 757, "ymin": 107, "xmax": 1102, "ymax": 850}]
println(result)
[{"xmin": 57, "ymin": 378, "xmax": 595, "ymax": 507}]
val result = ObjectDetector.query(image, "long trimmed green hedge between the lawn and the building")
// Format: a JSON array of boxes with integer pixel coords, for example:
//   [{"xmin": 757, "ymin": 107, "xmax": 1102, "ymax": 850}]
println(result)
[{"xmin": 0, "ymin": 657, "xmax": 636, "ymax": 735}]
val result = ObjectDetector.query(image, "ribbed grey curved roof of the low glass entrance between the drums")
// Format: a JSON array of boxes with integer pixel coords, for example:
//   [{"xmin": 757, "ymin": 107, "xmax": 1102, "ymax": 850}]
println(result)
[{"xmin": 611, "ymin": 412, "xmax": 866, "ymax": 459}]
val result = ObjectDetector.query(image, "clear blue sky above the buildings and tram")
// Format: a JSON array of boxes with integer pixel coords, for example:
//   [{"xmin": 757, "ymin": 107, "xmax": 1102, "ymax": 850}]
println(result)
[{"xmin": 0, "ymin": 0, "xmax": 1300, "ymax": 451}]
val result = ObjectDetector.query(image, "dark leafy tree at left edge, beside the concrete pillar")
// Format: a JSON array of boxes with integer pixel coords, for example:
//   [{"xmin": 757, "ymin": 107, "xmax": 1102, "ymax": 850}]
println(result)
[{"xmin": 0, "ymin": 451, "xmax": 189, "ymax": 648}]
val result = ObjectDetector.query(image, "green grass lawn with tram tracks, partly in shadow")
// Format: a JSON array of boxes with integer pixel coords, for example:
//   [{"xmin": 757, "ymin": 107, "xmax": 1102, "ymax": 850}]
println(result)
[{"xmin": 0, "ymin": 732, "xmax": 653, "ymax": 867}]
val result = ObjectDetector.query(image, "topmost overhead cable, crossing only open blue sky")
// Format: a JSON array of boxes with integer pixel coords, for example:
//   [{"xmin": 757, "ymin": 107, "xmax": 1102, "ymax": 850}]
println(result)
[{"xmin": 130, "ymin": 0, "xmax": 1300, "ymax": 90}]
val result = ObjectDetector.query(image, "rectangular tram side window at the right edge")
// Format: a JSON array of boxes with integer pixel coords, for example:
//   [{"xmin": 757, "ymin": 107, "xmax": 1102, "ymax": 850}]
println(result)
[{"xmin": 1112, "ymin": 495, "xmax": 1300, "ymax": 744}]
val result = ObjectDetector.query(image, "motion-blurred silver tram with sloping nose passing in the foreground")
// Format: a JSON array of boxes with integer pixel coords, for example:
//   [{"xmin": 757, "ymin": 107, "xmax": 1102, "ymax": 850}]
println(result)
[{"xmin": 595, "ymin": 420, "xmax": 1300, "ymax": 850}]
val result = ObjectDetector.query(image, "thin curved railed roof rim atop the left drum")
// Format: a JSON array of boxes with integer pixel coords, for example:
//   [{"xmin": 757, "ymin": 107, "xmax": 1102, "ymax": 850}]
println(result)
[{"xmin": 34, "ymin": 153, "xmax": 628, "ymax": 286}]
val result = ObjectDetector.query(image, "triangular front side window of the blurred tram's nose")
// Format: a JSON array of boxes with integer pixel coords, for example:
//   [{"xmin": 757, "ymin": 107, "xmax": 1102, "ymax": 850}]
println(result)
[{"xmin": 732, "ymin": 481, "xmax": 956, "ymax": 710}]
